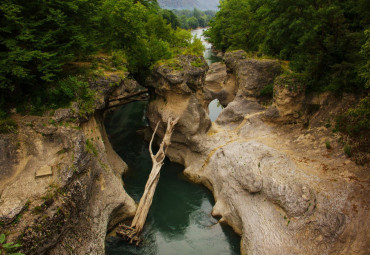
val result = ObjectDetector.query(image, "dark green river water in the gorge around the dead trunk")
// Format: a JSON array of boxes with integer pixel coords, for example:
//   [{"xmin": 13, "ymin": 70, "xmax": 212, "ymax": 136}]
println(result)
[{"xmin": 105, "ymin": 28, "xmax": 240, "ymax": 255}]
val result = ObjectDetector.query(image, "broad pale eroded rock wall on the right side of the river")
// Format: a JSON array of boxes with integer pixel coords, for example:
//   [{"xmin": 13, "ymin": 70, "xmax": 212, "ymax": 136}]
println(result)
[{"xmin": 147, "ymin": 52, "xmax": 369, "ymax": 254}]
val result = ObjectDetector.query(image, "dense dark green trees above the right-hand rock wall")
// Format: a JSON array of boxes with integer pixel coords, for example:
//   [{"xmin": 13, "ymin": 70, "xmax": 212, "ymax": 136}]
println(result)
[{"xmin": 207, "ymin": 0, "xmax": 370, "ymax": 93}]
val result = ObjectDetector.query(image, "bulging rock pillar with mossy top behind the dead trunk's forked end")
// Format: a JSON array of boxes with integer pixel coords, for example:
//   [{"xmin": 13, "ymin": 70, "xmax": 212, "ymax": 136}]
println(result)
[{"xmin": 147, "ymin": 56, "xmax": 211, "ymax": 163}]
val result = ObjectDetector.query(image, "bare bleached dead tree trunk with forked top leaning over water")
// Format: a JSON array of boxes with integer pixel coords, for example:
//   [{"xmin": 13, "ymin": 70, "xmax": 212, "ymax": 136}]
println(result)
[{"xmin": 117, "ymin": 118, "xmax": 179, "ymax": 245}]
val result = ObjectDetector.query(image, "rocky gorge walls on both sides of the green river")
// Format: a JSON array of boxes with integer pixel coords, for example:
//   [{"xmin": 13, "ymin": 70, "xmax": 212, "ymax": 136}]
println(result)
[{"xmin": 0, "ymin": 51, "xmax": 370, "ymax": 254}]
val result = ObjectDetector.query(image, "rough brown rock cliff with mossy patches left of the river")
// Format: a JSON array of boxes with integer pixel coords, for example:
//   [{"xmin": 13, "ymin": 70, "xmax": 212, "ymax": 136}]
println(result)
[{"xmin": 0, "ymin": 76, "xmax": 143, "ymax": 255}]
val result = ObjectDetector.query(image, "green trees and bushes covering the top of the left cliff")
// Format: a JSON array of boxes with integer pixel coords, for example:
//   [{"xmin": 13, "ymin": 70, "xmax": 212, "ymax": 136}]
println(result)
[{"xmin": 0, "ymin": 0, "xmax": 202, "ymax": 116}]
